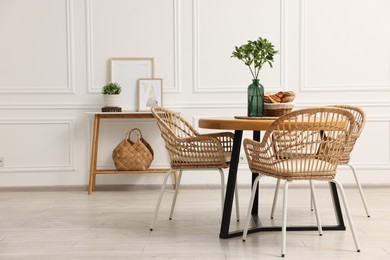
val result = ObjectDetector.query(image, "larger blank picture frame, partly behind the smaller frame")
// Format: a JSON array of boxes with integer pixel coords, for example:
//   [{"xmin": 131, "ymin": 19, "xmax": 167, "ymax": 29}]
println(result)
[{"xmin": 110, "ymin": 57, "xmax": 154, "ymax": 111}]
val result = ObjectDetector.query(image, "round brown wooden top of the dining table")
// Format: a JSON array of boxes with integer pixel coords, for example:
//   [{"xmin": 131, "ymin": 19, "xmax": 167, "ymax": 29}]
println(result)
[{"xmin": 199, "ymin": 117, "xmax": 277, "ymax": 130}]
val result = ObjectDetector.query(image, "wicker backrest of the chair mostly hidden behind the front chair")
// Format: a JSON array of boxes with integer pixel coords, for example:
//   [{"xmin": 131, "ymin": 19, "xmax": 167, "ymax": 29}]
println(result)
[{"xmin": 333, "ymin": 105, "xmax": 366, "ymax": 164}]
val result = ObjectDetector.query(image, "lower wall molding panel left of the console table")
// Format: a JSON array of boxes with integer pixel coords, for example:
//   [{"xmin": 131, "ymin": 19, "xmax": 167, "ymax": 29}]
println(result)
[{"xmin": 0, "ymin": 118, "xmax": 76, "ymax": 174}]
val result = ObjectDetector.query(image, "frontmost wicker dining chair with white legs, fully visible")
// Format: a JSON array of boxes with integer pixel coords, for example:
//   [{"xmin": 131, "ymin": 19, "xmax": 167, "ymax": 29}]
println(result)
[{"xmin": 242, "ymin": 107, "xmax": 360, "ymax": 256}]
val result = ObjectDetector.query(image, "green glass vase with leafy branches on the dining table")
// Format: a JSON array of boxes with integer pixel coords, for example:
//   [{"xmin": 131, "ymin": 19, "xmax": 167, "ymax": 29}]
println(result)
[{"xmin": 231, "ymin": 37, "xmax": 278, "ymax": 117}]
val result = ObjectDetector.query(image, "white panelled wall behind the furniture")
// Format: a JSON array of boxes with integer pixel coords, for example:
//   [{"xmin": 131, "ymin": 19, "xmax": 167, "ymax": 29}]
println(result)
[{"xmin": 0, "ymin": 0, "xmax": 390, "ymax": 187}]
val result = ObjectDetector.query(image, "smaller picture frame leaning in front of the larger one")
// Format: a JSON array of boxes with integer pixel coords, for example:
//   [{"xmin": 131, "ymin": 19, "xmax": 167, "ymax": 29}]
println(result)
[{"xmin": 138, "ymin": 78, "xmax": 163, "ymax": 112}]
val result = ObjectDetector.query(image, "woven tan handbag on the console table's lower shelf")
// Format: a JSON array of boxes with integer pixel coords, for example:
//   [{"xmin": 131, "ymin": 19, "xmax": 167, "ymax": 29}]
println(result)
[{"xmin": 112, "ymin": 128, "xmax": 154, "ymax": 171}]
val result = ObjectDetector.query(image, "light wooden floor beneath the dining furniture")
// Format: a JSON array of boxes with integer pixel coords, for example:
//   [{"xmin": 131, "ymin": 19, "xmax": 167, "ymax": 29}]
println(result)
[{"xmin": 0, "ymin": 185, "xmax": 390, "ymax": 260}]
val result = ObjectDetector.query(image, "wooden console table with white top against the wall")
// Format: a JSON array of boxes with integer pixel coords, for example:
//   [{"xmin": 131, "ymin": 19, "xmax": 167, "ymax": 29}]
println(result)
[{"xmin": 87, "ymin": 112, "xmax": 176, "ymax": 194}]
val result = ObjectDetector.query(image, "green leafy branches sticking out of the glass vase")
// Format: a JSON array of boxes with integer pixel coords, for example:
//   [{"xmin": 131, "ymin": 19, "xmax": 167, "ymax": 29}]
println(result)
[{"xmin": 231, "ymin": 37, "xmax": 278, "ymax": 79}]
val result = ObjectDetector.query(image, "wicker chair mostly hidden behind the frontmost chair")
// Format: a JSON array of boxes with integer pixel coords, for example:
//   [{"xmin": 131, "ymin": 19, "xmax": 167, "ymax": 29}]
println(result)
[{"xmin": 271, "ymin": 105, "xmax": 370, "ymax": 219}]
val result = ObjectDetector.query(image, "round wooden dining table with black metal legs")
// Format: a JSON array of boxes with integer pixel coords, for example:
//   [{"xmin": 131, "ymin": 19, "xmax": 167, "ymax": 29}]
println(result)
[{"xmin": 199, "ymin": 116, "xmax": 346, "ymax": 238}]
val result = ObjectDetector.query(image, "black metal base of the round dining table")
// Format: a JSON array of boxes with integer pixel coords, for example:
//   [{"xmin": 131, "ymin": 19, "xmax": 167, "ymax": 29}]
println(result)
[{"xmin": 219, "ymin": 130, "xmax": 346, "ymax": 238}]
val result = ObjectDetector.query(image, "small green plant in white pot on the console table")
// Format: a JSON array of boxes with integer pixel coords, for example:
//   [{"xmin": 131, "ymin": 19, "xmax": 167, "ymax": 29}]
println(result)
[{"xmin": 102, "ymin": 82, "xmax": 122, "ymax": 112}]
